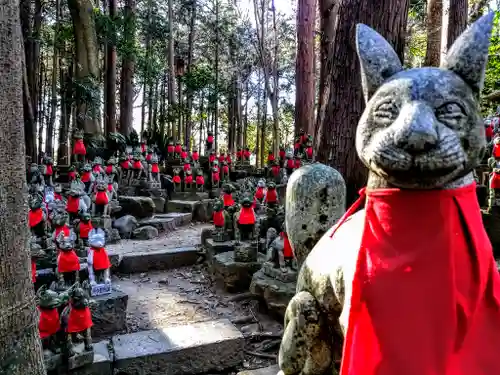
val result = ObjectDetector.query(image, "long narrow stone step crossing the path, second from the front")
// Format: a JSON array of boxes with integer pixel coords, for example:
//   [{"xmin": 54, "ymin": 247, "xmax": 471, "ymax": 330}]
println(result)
[{"xmin": 119, "ymin": 247, "xmax": 199, "ymax": 273}]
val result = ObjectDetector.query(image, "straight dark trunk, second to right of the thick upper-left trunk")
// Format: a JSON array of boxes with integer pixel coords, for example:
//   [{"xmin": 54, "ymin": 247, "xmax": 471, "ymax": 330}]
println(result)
[{"xmin": 120, "ymin": 0, "xmax": 135, "ymax": 136}]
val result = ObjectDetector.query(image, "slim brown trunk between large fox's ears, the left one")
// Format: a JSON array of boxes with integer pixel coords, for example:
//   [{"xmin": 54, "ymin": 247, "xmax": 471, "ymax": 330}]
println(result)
[{"xmin": 424, "ymin": 0, "xmax": 443, "ymax": 66}]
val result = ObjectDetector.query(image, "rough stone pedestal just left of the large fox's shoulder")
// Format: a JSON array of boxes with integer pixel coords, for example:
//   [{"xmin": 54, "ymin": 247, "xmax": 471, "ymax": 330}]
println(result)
[{"xmin": 250, "ymin": 262, "xmax": 297, "ymax": 319}]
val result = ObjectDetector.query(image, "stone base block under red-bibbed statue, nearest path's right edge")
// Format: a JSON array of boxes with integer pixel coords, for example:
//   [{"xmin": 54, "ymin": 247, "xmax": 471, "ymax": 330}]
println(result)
[{"xmin": 212, "ymin": 251, "xmax": 265, "ymax": 293}]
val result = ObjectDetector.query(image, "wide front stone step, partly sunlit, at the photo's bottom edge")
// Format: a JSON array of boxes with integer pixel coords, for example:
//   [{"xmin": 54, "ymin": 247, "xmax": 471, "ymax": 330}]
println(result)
[{"xmin": 113, "ymin": 319, "xmax": 245, "ymax": 375}]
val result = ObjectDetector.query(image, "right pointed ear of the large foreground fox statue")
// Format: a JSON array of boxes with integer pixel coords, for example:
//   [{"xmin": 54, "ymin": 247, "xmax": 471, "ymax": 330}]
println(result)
[{"xmin": 441, "ymin": 12, "xmax": 495, "ymax": 94}]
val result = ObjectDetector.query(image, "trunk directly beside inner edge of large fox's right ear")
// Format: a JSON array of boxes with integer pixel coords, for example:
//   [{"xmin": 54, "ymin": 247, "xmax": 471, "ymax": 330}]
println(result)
[{"xmin": 441, "ymin": 0, "xmax": 468, "ymax": 60}]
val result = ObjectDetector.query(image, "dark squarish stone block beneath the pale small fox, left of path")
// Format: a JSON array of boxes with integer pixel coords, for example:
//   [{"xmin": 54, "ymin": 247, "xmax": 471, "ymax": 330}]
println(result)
[{"xmin": 90, "ymin": 289, "xmax": 128, "ymax": 337}]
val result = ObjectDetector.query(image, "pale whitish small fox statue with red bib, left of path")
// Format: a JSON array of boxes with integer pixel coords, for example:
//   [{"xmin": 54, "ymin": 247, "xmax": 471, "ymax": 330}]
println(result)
[{"xmin": 87, "ymin": 228, "xmax": 111, "ymax": 295}]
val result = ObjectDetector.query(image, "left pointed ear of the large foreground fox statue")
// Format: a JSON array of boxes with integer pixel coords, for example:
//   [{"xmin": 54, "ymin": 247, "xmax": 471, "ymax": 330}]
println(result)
[{"xmin": 356, "ymin": 23, "xmax": 403, "ymax": 102}]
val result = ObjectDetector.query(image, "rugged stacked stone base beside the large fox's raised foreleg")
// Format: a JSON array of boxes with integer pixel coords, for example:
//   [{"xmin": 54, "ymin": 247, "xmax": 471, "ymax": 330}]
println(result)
[{"xmin": 250, "ymin": 270, "xmax": 296, "ymax": 319}]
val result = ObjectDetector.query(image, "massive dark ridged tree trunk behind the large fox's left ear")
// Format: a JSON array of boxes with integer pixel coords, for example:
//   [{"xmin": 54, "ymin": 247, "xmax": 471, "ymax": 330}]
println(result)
[{"xmin": 315, "ymin": 0, "xmax": 409, "ymax": 207}]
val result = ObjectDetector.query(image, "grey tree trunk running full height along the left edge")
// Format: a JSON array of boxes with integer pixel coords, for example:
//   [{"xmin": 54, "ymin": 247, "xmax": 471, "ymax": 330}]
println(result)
[{"xmin": 0, "ymin": 0, "xmax": 46, "ymax": 375}]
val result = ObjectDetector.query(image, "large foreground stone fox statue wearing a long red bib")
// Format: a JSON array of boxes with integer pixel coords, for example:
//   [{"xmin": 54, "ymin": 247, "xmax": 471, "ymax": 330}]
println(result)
[{"xmin": 279, "ymin": 14, "xmax": 500, "ymax": 375}]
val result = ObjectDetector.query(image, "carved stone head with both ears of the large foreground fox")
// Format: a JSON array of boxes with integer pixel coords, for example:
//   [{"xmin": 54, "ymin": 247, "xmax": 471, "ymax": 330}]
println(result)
[{"xmin": 356, "ymin": 13, "xmax": 493, "ymax": 189}]
